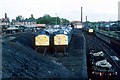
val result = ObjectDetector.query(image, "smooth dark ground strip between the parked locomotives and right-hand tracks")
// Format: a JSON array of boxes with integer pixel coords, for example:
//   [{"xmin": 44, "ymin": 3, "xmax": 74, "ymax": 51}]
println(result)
[{"xmin": 52, "ymin": 30, "xmax": 85, "ymax": 79}]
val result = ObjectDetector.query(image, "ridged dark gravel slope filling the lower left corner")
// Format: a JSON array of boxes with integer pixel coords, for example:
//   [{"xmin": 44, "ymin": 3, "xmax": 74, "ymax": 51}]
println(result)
[{"xmin": 2, "ymin": 34, "xmax": 72, "ymax": 78}]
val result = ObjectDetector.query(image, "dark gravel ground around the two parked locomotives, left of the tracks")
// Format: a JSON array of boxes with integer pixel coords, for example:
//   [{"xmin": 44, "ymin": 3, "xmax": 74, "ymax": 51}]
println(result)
[{"xmin": 2, "ymin": 30, "xmax": 86, "ymax": 79}]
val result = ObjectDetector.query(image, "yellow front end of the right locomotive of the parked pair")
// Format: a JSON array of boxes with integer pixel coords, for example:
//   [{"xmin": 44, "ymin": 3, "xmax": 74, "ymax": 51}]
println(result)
[{"xmin": 54, "ymin": 34, "xmax": 68, "ymax": 45}]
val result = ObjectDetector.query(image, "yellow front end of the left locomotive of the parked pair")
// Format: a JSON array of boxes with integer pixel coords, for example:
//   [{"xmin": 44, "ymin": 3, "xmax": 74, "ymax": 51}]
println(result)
[{"xmin": 35, "ymin": 35, "xmax": 49, "ymax": 46}]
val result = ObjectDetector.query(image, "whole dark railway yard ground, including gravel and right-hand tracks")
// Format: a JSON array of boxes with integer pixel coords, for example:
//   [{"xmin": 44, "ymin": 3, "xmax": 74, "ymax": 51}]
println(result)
[{"xmin": 1, "ymin": 28, "xmax": 120, "ymax": 80}]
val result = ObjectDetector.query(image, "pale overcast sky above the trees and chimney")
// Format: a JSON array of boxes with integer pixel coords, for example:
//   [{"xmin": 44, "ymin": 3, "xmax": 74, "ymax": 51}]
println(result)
[{"xmin": 0, "ymin": 0, "xmax": 120, "ymax": 21}]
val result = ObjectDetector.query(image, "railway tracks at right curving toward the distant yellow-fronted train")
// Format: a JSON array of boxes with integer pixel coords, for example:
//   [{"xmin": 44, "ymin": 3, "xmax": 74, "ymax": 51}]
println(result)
[{"xmin": 84, "ymin": 31, "xmax": 120, "ymax": 69}]
